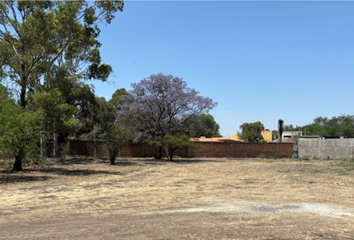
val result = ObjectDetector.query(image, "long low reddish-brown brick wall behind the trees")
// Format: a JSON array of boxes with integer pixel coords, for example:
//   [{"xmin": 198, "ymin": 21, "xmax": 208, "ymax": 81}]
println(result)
[{"xmin": 70, "ymin": 141, "xmax": 293, "ymax": 158}]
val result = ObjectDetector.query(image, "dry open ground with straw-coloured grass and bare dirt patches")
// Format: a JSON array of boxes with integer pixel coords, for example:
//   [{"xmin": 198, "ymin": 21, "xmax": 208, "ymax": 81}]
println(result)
[{"xmin": 0, "ymin": 157, "xmax": 354, "ymax": 239}]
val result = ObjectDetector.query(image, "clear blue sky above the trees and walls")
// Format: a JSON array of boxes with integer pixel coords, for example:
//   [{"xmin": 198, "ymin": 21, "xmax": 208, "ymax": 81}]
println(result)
[{"xmin": 93, "ymin": 1, "xmax": 354, "ymax": 137}]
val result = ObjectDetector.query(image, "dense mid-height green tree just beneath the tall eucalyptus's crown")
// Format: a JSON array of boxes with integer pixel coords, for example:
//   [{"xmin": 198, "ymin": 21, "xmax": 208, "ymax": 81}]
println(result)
[{"xmin": 26, "ymin": 76, "xmax": 97, "ymax": 157}]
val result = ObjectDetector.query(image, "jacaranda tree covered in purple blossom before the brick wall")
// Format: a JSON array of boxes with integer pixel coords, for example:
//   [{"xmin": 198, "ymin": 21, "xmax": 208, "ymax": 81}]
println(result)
[{"xmin": 121, "ymin": 73, "xmax": 217, "ymax": 160}]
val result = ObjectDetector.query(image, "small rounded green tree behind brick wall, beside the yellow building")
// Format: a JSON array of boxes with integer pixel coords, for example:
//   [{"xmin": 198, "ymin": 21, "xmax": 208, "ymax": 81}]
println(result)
[{"xmin": 238, "ymin": 121, "xmax": 264, "ymax": 142}]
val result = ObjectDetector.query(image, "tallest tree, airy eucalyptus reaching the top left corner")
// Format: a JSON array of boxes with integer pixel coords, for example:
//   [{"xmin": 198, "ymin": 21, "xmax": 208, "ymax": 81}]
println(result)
[{"xmin": 0, "ymin": 0, "xmax": 124, "ymax": 169}]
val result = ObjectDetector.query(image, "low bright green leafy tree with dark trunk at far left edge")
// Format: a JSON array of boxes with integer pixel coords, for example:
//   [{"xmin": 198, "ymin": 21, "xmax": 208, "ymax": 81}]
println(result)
[{"xmin": 0, "ymin": 85, "xmax": 41, "ymax": 171}]
